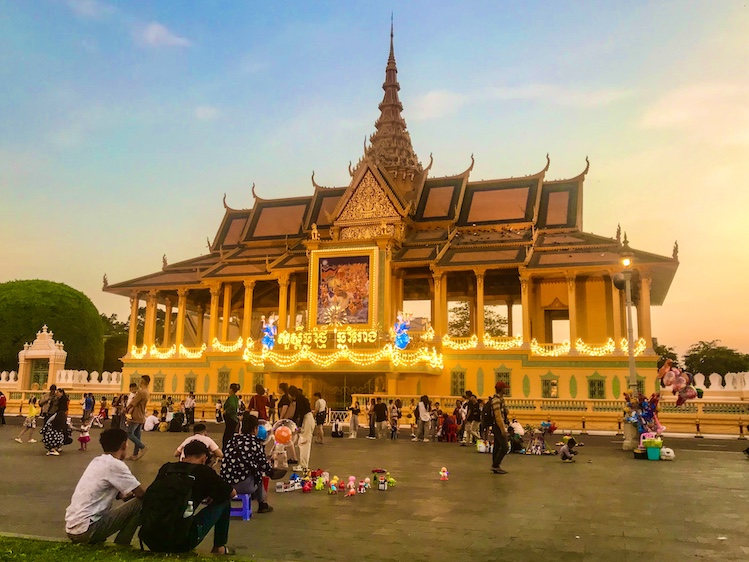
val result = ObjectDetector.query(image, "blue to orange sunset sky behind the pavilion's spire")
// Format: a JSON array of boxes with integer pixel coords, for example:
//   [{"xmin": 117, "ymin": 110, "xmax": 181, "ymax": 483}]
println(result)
[{"xmin": 0, "ymin": 0, "xmax": 749, "ymax": 353}]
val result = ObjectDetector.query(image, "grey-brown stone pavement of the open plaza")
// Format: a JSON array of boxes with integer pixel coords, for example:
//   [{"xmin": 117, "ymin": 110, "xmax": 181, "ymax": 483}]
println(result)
[{"xmin": 0, "ymin": 420, "xmax": 749, "ymax": 562}]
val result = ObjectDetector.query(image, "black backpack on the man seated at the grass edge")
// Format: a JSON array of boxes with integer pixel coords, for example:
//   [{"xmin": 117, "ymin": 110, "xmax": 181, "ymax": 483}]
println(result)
[{"xmin": 138, "ymin": 463, "xmax": 196, "ymax": 552}]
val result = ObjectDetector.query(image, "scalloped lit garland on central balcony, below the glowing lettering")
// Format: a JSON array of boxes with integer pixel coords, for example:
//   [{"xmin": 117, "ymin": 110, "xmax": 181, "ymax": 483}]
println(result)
[{"xmin": 242, "ymin": 344, "xmax": 444, "ymax": 369}]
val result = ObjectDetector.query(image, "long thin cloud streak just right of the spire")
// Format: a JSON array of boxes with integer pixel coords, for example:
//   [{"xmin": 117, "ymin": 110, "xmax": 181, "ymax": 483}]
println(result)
[{"xmin": 414, "ymin": 84, "xmax": 634, "ymax": 120}]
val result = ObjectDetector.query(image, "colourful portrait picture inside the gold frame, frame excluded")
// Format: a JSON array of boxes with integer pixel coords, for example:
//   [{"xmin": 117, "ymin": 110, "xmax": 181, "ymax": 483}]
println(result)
[{"xmin": 317, "ymin": 255, "xmax": 370, "ymax": 325}]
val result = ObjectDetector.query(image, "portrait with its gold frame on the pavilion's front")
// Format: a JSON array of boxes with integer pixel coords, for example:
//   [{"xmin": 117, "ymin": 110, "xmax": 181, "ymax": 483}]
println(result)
[{"xmin": 309, "ymin": 248, "xmax": 377, "ymax": 328}]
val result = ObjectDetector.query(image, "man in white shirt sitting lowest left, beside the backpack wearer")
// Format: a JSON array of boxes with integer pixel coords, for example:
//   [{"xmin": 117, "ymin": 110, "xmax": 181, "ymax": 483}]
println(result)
[{"xmin": 65, "ymin": 428, "xmax": 145, "ymax": 546}]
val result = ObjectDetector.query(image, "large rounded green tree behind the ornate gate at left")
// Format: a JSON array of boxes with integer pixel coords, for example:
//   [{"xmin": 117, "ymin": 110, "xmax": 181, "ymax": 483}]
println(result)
[{"xmin": 0, "ymin": 279, "xmax": 104, "ymax": 371}]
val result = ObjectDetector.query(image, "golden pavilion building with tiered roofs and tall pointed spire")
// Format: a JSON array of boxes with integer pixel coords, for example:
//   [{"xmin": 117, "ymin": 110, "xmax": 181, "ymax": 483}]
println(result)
[{"xmin": 104, "ymin": 33, "xmax": 678, "ymax": 416}]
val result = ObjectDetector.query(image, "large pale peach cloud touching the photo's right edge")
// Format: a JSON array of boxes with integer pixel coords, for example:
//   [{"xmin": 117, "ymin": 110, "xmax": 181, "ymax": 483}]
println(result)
[{"xmin": 639, "ymin": 82, "xmax": 749, "ymax": 145}]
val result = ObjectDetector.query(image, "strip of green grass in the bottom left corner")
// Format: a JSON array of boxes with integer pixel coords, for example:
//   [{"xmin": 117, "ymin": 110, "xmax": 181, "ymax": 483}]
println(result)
[{"xmin": 0, "ymin": 536, "xmax": 249, "ymax": 562}]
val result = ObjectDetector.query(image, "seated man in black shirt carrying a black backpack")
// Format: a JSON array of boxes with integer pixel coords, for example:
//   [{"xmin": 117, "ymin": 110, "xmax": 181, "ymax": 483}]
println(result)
[{"xmin": 156, "ymin": 441, "xmax": 237, "ymax": 554}]
